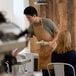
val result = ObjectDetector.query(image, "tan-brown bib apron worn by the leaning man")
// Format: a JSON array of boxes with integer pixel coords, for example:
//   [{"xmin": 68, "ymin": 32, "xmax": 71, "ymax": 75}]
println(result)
[{"xmin": 33, "ymin": 21, "xmax": 56, "ymax": 70}]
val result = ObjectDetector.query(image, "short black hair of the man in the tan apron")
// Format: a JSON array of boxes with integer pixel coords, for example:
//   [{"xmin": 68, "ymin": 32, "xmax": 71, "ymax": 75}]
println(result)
[{"xmin": 24, "ymin": 6, "xmax": 38, "ymax": 16}]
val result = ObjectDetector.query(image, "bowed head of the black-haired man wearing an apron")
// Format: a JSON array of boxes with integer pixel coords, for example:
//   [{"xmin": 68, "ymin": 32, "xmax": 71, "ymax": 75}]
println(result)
[{"xmin": 24, "ymin": 6, "xmax": 38, "ymax": 23}]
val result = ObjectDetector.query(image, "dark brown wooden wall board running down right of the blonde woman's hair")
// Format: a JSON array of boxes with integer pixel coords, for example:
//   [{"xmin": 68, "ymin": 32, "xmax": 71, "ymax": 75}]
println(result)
[{"xmin": 67, "ymin": 0, "xmax": 75, "ymax": 47}]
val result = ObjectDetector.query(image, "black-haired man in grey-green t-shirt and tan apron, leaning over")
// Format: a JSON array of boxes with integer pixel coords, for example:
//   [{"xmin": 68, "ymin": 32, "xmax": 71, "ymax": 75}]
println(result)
[{"xmin": 13, "ymin": 6, "xmax": 59, "ymax": 75}]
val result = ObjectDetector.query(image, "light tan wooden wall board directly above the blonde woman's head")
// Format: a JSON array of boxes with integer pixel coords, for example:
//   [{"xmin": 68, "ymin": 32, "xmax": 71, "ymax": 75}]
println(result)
[{"xmin": 56, "ymin": 0, "xmax": 67, "ymax": 30}]
